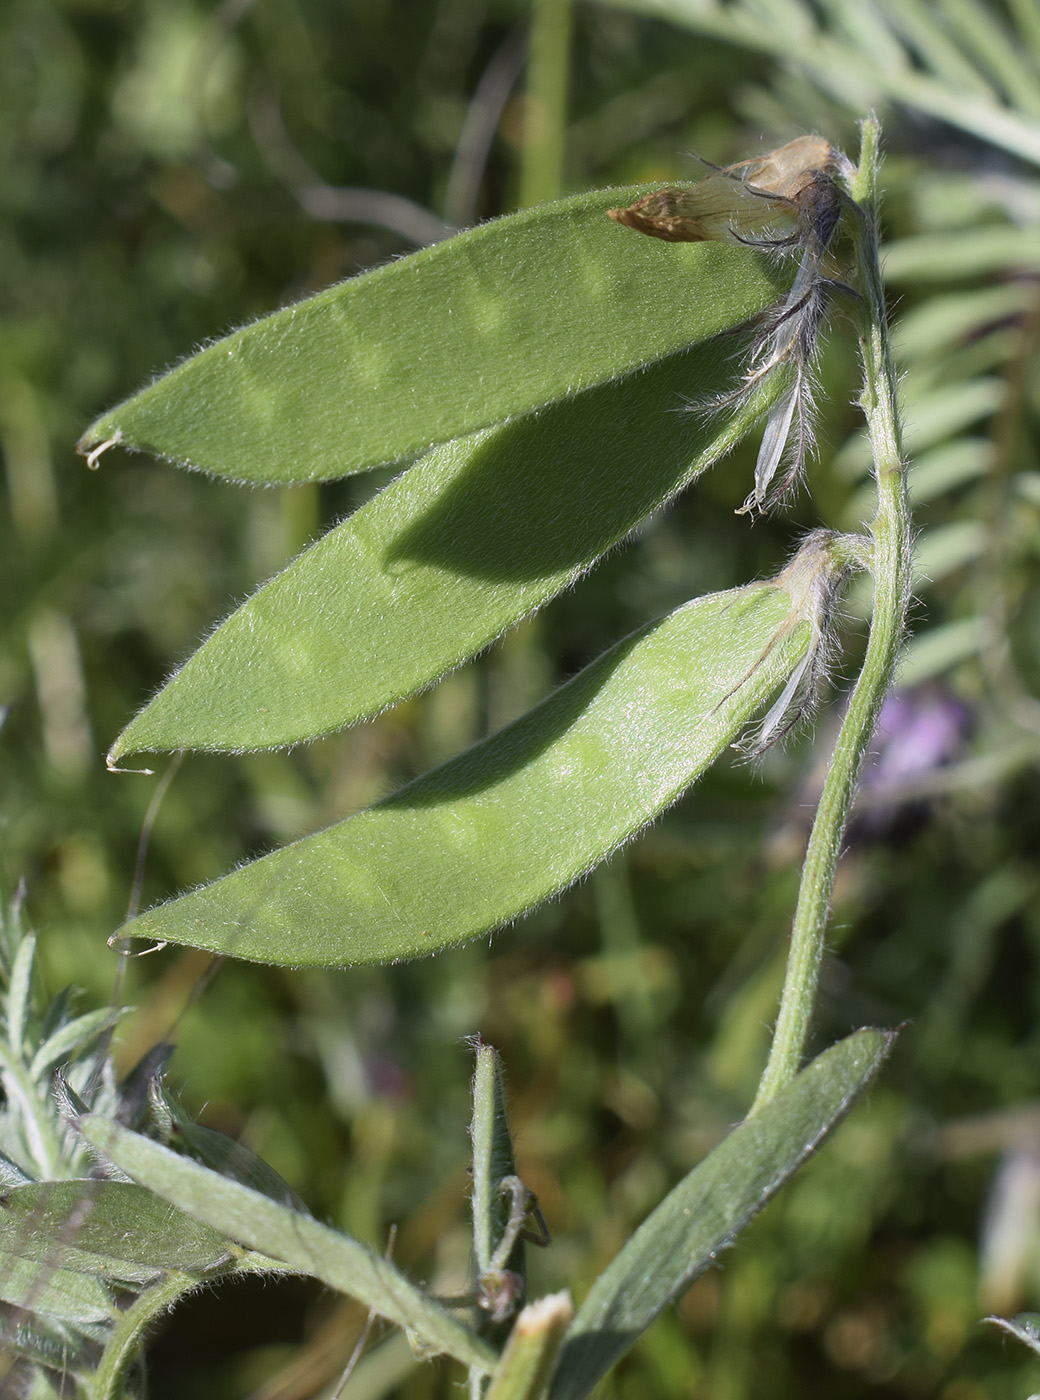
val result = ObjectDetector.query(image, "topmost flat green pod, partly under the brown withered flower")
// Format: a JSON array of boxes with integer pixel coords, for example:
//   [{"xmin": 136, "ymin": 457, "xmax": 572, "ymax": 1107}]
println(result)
[{"xmin": 80, "ymin": 188, "xmax": 784, "ymax": 482}]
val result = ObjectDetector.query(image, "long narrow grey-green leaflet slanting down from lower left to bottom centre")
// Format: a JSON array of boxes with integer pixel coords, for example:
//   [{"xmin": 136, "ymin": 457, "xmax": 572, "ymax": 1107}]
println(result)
[{"xmin": 76, "ymin": 1114, "xmax": 496, "ymax": 1372}]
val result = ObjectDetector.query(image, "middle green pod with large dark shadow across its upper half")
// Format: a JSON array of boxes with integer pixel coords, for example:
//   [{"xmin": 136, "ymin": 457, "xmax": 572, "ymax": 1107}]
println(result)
[{"xmin": 111, "ymin": 338, "xmax": 783, "ymax": 760}]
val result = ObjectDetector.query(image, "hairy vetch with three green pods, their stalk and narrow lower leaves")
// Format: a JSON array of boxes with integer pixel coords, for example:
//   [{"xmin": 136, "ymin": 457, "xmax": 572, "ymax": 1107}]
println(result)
[{"xmin": 59, "ymin": 119, "xmax": 910, "ymax": 1400}]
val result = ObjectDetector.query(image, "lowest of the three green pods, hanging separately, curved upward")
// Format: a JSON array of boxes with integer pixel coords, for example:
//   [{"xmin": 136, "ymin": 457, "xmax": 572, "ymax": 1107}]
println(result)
[{"xmin": 123, "ymin": 566, "xmax": 813, "ymax": 966}]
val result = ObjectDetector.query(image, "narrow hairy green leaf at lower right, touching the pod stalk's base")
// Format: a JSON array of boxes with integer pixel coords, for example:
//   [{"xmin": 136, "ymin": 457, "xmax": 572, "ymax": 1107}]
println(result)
[{"xmin": 550, "ymin": 1030, "xmax": 894, "ymax": 1400}]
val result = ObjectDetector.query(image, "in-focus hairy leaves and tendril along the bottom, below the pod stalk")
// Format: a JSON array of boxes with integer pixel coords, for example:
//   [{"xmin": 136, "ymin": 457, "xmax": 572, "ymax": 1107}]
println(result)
[{"xmin": 0, "ymin": 904, "xmax": 889, "ymax": 1400}]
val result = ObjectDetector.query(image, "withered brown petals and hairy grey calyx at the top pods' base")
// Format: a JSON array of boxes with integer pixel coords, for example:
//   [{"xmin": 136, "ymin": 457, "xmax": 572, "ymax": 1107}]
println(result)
[{"xmin": 609, "ymin": 136, "xmax": 848, "ymax": 511}]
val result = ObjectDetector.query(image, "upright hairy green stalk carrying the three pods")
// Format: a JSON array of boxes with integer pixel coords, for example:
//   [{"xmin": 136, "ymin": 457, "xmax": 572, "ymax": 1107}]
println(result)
[{"xmin": 752, "ymin": 118, "xmax": 911, "ymax": 1113}]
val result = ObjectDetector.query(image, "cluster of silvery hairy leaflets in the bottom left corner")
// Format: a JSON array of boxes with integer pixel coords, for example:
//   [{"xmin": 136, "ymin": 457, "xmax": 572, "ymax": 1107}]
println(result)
[{"xmin": 0, "ymin": 899, "xmax": 291, "ymax": 1400}]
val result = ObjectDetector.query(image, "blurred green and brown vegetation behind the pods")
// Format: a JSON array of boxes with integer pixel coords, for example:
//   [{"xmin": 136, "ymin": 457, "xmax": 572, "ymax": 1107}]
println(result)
[{"xmin": 0, "ymin": 0, "xmax": 1040, "ymax": 1400}]
